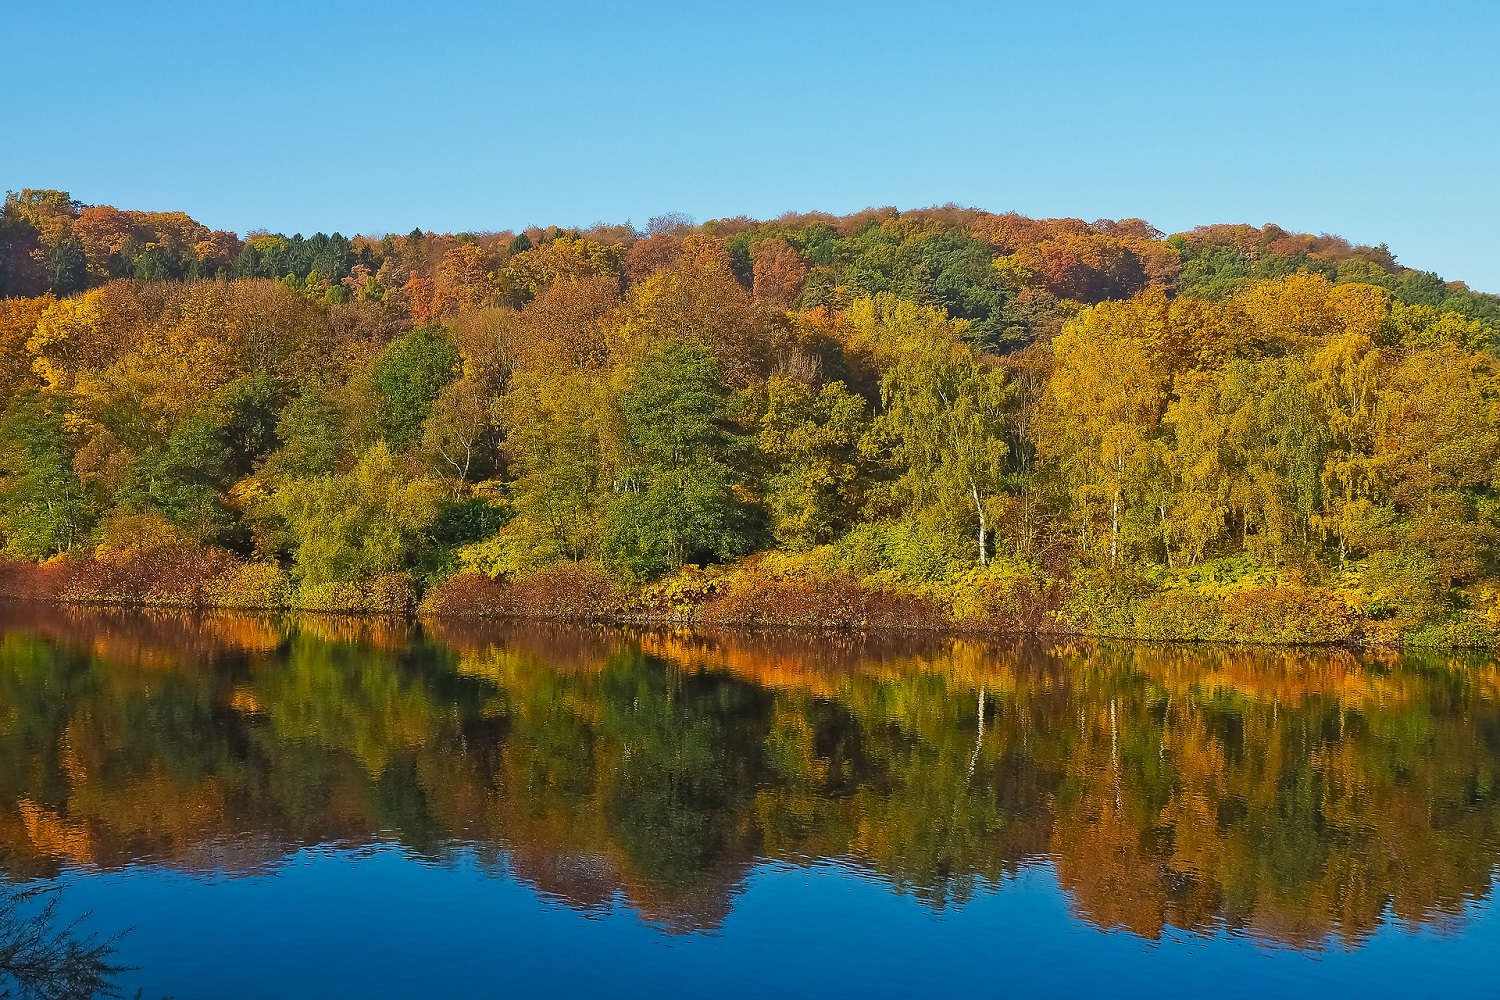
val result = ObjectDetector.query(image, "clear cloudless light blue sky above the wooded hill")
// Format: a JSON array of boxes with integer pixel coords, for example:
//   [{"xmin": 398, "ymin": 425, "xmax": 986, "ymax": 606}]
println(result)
[{"xmin": 0, "ymin": 0, "xmax": 1500, "ymax": 292}]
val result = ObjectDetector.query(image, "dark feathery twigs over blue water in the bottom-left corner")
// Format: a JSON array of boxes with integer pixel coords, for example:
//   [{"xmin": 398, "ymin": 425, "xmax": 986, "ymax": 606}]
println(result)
[{"xmin": 0, "ymin": 882, "xmax": 126, "ymax": 1000}]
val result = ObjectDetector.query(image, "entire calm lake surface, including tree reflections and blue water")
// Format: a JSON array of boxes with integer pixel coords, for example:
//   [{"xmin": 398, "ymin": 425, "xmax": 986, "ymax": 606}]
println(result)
[{"xmin": 0, "ymin": 606, "xmax": 1500, "ymax": 1000}]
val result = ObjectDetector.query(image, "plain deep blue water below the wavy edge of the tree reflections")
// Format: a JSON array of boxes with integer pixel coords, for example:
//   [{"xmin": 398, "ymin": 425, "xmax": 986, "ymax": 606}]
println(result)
[{"xmin": 52, "ymin": 847, "xmax": 1500, "ymax": 997}]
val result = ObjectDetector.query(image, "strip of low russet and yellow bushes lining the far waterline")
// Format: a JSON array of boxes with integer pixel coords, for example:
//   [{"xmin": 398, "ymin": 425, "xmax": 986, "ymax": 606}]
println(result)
[{"xmin": 0, "ymin": 547, "xmax": 1482, "ymax": 649}]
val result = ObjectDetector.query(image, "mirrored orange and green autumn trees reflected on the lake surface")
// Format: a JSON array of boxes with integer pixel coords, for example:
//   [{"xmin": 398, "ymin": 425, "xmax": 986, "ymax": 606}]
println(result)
[{"xmin": 0, "ymin": 609, "xmax": 1500, "ymax": 943}]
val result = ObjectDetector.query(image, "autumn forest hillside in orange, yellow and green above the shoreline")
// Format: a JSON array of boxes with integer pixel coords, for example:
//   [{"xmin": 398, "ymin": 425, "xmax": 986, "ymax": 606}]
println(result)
[{"xmin": 0, "ymin": 189, "xmax": 1500, "ymax": 648}]
